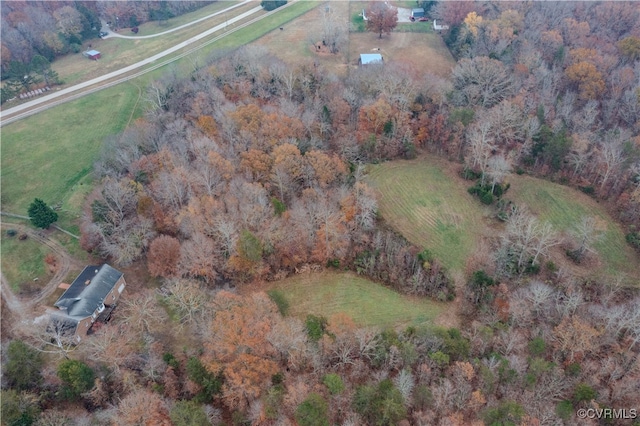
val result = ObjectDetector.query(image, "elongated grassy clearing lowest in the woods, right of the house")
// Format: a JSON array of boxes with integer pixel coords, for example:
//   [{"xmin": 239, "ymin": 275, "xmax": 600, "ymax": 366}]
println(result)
[{"xmin": 265, "ymin": 272, "xmax": 446, "ymax": 328}]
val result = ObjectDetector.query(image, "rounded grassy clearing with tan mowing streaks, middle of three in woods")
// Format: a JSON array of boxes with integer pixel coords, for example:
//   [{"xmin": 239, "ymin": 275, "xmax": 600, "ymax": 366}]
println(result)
[{"xmin": 367, "ymin": 157, "xmax": 490, "ymax": 271}]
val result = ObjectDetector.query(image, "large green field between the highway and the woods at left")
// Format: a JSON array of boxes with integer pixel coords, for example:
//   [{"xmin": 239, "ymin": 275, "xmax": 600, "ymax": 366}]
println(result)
[{"xmin": 1, "ymin": 85, "xmax": 139, "ymax": 216}]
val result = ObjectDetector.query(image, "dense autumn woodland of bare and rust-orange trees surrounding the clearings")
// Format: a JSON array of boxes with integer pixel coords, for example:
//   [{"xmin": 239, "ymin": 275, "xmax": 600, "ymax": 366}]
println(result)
[{"xmin": 2, "ymin": 2, "xmax": 640, "ymax": 425}]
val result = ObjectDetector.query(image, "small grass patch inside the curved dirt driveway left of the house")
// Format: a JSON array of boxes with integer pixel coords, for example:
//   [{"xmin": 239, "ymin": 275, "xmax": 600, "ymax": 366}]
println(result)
[{"xmin": 0, "ymin": 225, "xmax": 52, "ymax": 293}]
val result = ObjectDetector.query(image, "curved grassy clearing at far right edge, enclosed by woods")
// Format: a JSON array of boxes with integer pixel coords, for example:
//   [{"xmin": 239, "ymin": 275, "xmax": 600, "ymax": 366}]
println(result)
[{"xmin": 506, "ymin": 175, "xmax": 640, "ymax": 285}]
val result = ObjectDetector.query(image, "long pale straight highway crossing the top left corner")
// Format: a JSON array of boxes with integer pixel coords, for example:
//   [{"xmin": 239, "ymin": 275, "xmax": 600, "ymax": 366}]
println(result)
[{"xmin": 0, "ymin": 2, "xmax": 264, "ymax": 126}]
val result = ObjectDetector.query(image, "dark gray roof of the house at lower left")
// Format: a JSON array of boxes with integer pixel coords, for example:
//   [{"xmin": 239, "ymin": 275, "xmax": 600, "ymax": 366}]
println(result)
[{"xmin": 54, "ymin": 263, "xmax": 123, "ymax": 318}]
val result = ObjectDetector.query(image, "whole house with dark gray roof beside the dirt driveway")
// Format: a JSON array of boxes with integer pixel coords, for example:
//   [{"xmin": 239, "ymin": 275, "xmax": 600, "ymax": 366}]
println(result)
[{"xmin": 50, "ymin": 263, "xmax": 127, "ymax": 343}]
